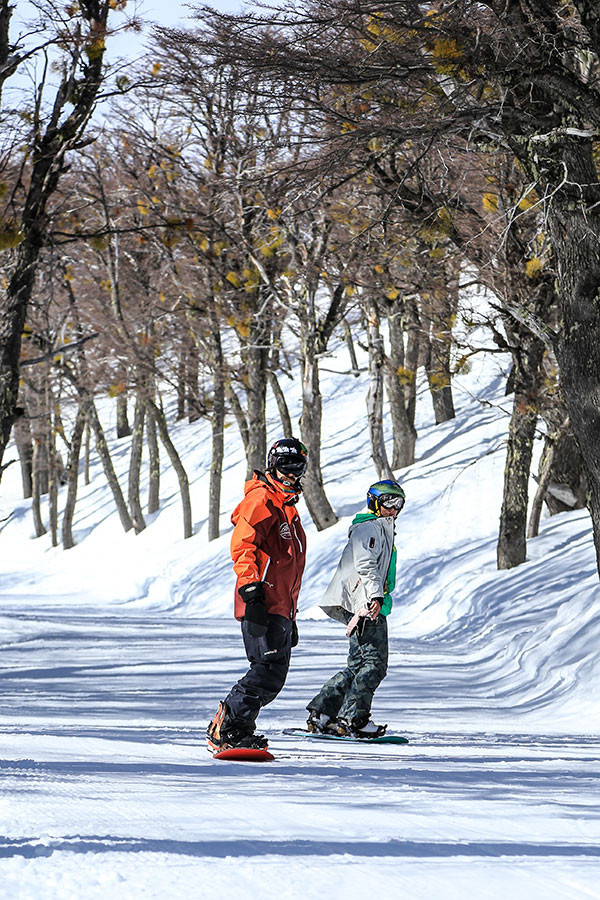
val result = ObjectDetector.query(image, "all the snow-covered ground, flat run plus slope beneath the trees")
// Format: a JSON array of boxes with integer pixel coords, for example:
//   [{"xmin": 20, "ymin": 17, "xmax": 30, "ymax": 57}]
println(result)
[{"xmin": 0, "ymin": 322, "xmax": 600, "ymax": 900}]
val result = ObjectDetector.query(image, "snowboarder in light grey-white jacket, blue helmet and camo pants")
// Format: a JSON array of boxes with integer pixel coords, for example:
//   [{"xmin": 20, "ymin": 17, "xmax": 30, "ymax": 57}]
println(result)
[{"xmin": 307, "ymin": 480, "xmax": 405, "ymax": 738}]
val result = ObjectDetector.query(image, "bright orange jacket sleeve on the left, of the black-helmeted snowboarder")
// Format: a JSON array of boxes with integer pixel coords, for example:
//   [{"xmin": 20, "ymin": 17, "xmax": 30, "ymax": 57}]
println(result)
[{"xmin": 231, "ymin": 495, "xmax": 271, "ymax": 587}]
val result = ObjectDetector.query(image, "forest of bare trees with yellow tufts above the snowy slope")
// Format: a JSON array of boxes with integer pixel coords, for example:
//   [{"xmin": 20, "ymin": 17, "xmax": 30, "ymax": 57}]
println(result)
[{"xmin": 0, "ymin": 0, "xmax": 600, "ymax": 568}]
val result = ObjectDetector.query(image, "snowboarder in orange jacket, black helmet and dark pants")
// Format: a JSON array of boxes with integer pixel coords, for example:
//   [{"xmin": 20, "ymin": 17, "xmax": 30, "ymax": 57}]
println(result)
[{"xmin": 207, "ymin": 438, "xmax": 307, "ymax": 751}]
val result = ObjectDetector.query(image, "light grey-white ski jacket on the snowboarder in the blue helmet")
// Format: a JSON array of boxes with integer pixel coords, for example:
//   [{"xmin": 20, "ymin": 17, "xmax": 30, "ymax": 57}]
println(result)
[{"xmin": 320, "ymin": 514, "xmax": 395, "ymax": 622}]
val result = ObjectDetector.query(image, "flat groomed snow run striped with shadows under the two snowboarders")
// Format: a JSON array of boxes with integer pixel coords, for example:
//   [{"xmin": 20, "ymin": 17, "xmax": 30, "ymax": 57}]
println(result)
[{"xmin": 0, "ymin": 606, "xmax": 600, "ymax": 900}]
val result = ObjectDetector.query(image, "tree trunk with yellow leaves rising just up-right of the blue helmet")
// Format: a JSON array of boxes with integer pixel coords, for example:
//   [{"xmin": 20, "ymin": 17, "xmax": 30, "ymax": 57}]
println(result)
[{"xmin": 385, "ymin": 308, "xmax": 417, "ymax": 469}]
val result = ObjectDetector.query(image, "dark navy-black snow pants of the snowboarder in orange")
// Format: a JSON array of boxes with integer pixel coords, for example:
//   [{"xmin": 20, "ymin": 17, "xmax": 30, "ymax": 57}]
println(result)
[{"xmin": 225, "ymin": 615, "xmax": 293, "ymax": 731}]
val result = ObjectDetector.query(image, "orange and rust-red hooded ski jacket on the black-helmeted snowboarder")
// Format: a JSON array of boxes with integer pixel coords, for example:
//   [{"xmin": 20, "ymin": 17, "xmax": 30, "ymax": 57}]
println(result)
[{"xmin": 231, "ymin": 472, "xmax": 306, "ymax": 619}]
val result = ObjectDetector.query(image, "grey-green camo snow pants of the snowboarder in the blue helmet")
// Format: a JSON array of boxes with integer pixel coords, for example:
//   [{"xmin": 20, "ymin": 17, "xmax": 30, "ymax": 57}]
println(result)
[{"xmin": 307, "ymin": 614, "xmax": 388, "ymax": 727}]
